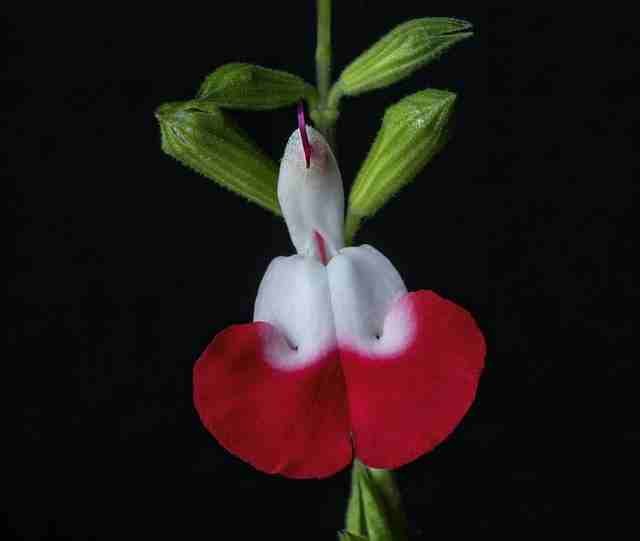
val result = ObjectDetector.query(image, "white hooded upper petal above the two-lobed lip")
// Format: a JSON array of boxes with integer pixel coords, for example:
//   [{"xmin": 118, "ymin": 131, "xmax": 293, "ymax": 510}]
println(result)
[{"xmin": 278, "ymin": 126, "xmax": 344, "ymax": 258}]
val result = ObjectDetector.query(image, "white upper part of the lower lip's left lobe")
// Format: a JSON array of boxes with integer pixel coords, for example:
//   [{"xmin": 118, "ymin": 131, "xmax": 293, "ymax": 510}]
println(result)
[{"xmin": 253, "ymin": 255, "xmax": 336, "ymax": 369}]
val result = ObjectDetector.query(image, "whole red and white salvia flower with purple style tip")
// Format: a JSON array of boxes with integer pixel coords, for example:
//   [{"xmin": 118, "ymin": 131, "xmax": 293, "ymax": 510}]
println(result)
[{"xmin": 194, "ymin": 108, "xmax": 485, "ymax": 478}]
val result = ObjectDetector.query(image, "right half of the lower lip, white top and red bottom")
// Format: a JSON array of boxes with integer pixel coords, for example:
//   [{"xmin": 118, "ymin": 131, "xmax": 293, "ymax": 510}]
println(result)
[{"xmin": 328, "ymin": 247, "xmax": 486, "ymax": 469}]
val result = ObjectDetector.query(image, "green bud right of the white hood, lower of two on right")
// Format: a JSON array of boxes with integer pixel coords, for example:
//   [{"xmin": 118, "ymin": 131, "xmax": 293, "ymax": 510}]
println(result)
[{"xmin": 346, "ymin": 89, "xmax": 456, "ymax": 239}]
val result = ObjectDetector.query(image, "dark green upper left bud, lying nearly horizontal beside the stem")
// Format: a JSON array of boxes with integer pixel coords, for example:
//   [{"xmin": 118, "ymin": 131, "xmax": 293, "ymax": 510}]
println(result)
[{"xmin": 197, "ymin": 62, "xmax": 317, "ymax": 111}]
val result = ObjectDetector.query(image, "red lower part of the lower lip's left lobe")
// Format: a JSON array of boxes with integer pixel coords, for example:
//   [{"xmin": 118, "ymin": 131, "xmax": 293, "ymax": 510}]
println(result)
[{"xmin": 193, "ymin": 322, "xmax": 352, "ymax": 478}]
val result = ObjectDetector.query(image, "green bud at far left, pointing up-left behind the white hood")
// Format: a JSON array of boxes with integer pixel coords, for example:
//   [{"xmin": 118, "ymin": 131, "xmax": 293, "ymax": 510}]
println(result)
[{"xmin": 155, "ymin": 100, "xmax": 281, "ymax": 215}]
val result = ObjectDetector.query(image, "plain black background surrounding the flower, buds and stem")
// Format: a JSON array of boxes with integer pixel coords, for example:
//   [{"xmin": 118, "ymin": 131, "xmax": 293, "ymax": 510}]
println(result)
[{"xmin": 3, "ymin": 1, "xmax": 638, "ymax": 540}]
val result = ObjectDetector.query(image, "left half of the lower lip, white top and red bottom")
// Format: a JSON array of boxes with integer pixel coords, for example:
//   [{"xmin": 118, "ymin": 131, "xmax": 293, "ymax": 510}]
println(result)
[{"xmin": 194, "ymin": 256, "xmax": 352, "ymax": 478}]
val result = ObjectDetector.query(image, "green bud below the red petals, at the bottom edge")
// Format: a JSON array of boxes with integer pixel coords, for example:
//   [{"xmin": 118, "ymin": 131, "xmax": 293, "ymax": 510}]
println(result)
[{"xmin": 346, "ymin": 460, "xmax": 408, "ymax": 541}]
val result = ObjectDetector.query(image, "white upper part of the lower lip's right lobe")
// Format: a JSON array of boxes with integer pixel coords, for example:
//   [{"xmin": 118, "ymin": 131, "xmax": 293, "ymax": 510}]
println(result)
[{"xmin": 327, "ymin": 245, "xmax": 413, "ymax": 356}]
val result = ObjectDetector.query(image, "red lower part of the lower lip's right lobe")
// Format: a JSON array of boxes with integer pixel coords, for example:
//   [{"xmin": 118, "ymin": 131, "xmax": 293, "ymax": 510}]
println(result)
[{"xmin": 340, "ymin": 291, "xmax": 486, "ymax": 469}]
